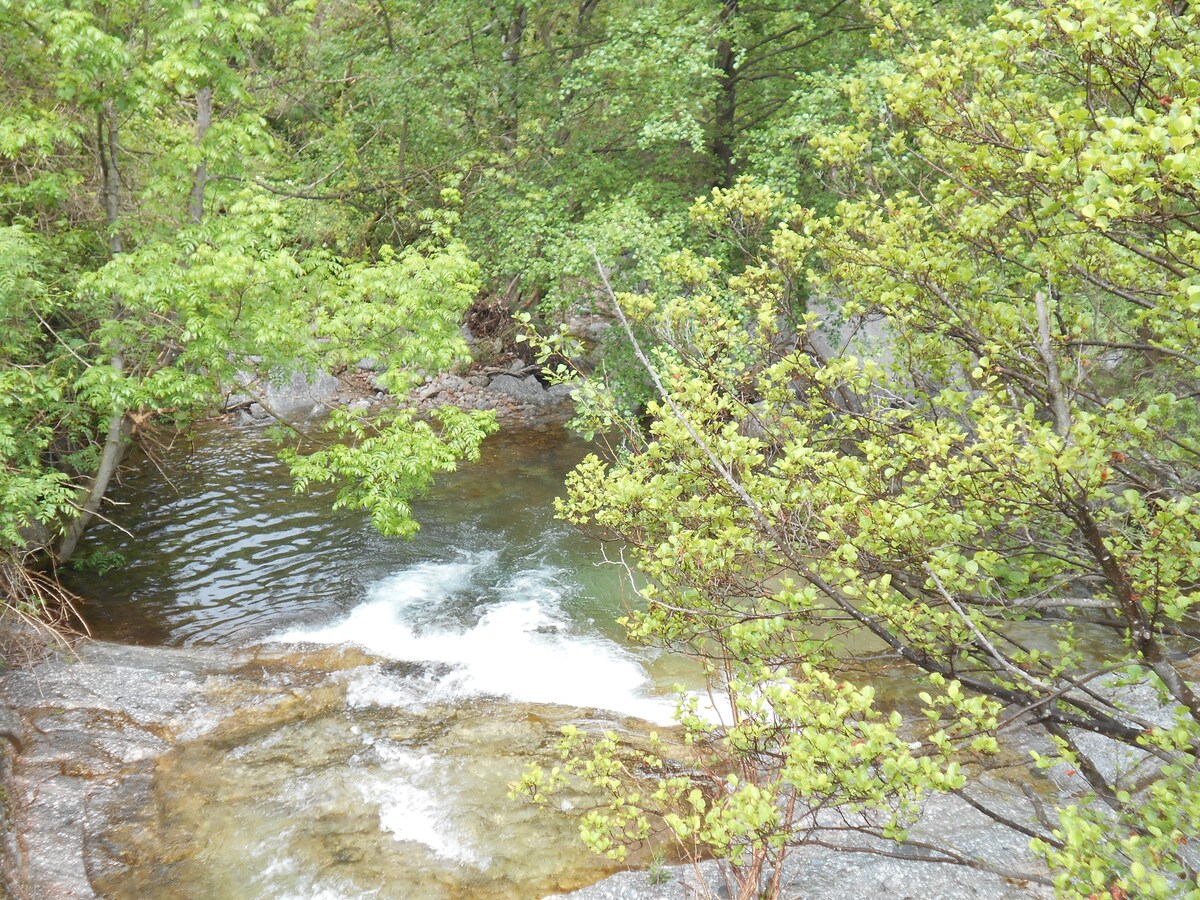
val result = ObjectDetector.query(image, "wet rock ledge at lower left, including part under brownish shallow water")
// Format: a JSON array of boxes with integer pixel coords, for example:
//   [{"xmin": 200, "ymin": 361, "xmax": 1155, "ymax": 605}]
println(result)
[{"xmin": 2, "ymin": 643, "xmax": 638, "ymax": 900}]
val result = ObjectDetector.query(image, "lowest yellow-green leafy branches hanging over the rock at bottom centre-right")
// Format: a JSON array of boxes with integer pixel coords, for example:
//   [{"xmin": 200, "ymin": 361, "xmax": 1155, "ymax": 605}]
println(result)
[{"xmin": 512, "ymin": 656, "xmax": 995, "ymax": 884}]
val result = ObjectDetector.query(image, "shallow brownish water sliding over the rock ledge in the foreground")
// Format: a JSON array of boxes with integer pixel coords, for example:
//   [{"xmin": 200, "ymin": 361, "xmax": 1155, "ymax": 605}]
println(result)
[{"xmin": 87, "ymin": 650, "xmax": 672, "ymax": 900}]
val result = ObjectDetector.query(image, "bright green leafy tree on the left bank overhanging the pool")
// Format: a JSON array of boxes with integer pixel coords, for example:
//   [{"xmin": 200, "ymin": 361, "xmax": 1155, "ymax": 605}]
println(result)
[{"xmin": 0, "ymin": 0, "xmax": 491, "ymax": 604}]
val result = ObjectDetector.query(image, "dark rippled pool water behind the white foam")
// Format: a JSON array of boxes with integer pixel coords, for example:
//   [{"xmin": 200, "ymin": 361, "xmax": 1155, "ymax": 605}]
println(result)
[{"xmin": 71, "ymin": 428, "xmax": 638, "ymax": 646}]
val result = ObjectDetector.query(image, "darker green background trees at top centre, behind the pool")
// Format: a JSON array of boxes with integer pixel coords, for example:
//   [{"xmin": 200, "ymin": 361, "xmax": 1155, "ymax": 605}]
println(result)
[{"xmin": 272, "ymin": 0, "xmax": 869, "ymax": 310}]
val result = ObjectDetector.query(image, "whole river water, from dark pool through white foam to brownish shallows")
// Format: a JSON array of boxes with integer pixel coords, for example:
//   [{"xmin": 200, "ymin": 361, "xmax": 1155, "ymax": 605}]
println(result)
[{"xmin": 63, "ymin": 428, "xmax": 697, "ymax": 898}]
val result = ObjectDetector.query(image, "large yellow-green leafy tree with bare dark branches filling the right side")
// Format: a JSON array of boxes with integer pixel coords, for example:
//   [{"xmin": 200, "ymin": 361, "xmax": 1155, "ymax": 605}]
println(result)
[{"xmin": 526, "ymin": 0, "xmax": 1200, "ymax": 896}]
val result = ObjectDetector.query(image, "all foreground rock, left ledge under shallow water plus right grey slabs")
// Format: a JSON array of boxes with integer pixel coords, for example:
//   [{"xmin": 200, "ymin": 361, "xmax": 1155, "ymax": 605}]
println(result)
[{"xmin": 0, "ymin": 642, "xmax": 1050, "ymax": 900}]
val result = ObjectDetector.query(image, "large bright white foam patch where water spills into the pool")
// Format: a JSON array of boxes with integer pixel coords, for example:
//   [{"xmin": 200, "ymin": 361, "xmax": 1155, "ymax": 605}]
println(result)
[{"xmin": 276, "ymin": 554, "xmax": 674, "ymax": 725}]
